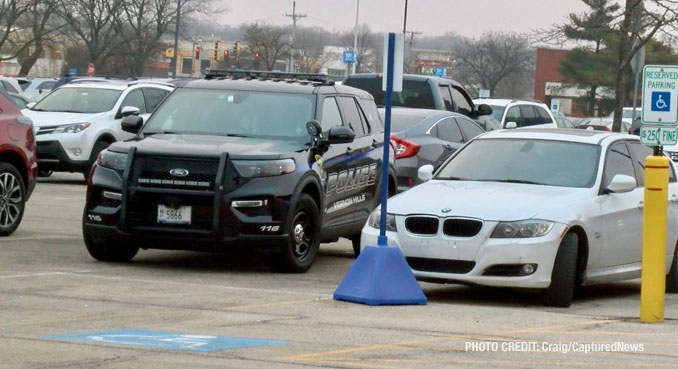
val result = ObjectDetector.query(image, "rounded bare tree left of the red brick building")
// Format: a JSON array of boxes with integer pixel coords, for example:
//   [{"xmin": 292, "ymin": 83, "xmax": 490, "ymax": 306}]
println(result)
[{"xmin": 454, "ymin": 32, "xmax": 534, "ymax": 96}]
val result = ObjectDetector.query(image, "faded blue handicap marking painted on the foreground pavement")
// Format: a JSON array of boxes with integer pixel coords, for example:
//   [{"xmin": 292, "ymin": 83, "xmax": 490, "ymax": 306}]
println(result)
[{"xmin": 42, "ymin": 329, "xmax": 287, "ymax": 352}]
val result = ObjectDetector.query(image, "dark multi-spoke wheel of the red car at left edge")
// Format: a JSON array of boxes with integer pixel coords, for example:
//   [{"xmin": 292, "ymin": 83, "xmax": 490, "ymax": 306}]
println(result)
[{"xmin": 0, "ymin": 163, "xmax": 26, "ymax": 236}]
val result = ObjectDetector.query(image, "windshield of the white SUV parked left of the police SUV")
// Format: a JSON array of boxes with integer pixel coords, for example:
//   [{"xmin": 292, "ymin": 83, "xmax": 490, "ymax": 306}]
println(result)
[{"xmin": 32, "ymin": 87, "xmax": 122, "ymax": 114}]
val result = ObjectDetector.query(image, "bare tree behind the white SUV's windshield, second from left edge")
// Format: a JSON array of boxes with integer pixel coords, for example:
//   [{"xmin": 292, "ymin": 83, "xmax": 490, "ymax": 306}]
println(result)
[{"xmin": 59, "ymin": 0, "xmax": 126, "ymax": 69}]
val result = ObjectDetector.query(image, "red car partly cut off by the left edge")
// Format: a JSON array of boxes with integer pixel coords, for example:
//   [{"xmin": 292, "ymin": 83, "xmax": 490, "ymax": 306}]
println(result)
[{"xmin": 0, "ymin": 87, "xmax": 38, "ymax": 236}]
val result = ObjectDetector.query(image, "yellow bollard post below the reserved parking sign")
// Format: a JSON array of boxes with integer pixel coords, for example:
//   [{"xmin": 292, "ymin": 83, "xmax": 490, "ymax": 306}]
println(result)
[{"xmin": 640, "ymin": 156, "xmax": 669, "ymax": 323}]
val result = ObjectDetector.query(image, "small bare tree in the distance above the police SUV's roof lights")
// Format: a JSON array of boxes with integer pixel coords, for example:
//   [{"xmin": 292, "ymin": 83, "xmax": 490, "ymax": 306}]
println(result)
[{"xmin": 244, "ymin": 22, "xmax": 289, "ymax": 70}]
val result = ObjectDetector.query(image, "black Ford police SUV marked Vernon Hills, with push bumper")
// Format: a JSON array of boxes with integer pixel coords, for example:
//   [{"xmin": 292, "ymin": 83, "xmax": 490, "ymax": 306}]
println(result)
[{"xmin": 83, "ymin": 70, "xmax": 396, "ymax": 272}]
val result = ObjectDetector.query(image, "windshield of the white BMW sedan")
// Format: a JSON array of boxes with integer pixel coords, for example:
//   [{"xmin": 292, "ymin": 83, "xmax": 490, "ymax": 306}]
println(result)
[{"xmin": 435, "ymin": 138, "xmax": 600, "ymax": 188}]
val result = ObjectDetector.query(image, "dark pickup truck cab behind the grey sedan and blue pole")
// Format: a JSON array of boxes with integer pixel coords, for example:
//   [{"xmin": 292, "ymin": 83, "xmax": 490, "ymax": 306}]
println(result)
[{"xmin": 343, "ymin": 73, "xmax": 491, "ymax": 128}]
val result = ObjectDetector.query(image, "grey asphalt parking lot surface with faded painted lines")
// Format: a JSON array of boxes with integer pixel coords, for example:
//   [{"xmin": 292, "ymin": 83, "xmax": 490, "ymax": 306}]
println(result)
[{"xmin": 0, "ymin": 174, "xmax": 678, "ymax": 369}]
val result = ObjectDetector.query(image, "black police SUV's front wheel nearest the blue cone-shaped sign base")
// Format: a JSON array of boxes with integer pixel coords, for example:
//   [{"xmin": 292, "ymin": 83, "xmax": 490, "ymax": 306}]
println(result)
[{"xmin": 267, "ymin": 194, "xmax": 320, "ymax": 273}]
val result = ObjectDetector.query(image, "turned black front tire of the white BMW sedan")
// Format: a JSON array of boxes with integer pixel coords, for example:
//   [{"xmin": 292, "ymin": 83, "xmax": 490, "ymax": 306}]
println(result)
[{"xmin": 544, "ymin": 233, "xmax": 579, "ymax": 308}]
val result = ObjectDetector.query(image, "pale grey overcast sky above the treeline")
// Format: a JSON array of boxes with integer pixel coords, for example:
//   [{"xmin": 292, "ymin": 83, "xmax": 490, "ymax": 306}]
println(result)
[{"xmin": 217, "ymin": 0, "xmax": 586, "ymax": 37}]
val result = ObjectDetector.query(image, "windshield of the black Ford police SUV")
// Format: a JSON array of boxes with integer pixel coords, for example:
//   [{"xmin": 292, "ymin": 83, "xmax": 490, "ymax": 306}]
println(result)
[{"xmin": 143, "ymin": 88, "xmax": 315, "ymax": 142}]
